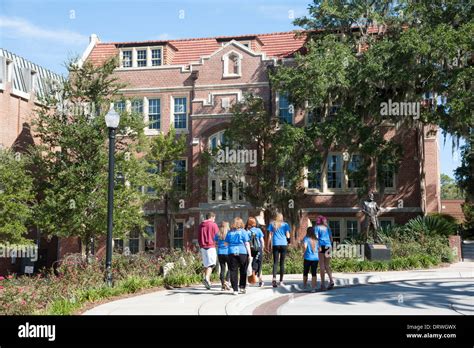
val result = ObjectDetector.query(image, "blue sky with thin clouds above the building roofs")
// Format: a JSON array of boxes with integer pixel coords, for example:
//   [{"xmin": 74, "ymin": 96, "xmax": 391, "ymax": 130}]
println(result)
[{"xmin": 0, "ymin": 0, "xmax": 460, "ymax": 177}]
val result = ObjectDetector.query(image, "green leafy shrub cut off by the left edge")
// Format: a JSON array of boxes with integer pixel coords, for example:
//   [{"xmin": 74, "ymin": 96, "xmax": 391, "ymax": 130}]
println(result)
[{"xmin": 0, "ymin": 149, "xmax": 34, "ymax": 244}]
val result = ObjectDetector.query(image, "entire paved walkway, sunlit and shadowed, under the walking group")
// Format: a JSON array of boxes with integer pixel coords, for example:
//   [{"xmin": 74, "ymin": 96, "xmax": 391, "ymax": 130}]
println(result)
[{"xmin": 84, "ymin": 262, "xmax": 474, "ymax": 315}]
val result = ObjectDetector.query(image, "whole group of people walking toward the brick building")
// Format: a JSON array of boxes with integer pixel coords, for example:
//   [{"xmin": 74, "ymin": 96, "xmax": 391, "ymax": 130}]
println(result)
[{"xmin": 198, "ymin": 212, "xmax": 334, "ymax": 295}]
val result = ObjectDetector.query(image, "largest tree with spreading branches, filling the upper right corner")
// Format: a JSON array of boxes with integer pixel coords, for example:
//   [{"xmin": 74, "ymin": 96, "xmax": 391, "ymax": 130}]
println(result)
[{"xmin": 272, "ymin": 0, "xmax": 474, "ymax": 201}]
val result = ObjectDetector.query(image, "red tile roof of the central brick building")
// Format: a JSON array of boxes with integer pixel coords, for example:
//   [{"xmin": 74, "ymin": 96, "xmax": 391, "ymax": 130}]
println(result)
[{"xmin": 87, "ymin": 31, "xmax": 305, "ymax": 65}]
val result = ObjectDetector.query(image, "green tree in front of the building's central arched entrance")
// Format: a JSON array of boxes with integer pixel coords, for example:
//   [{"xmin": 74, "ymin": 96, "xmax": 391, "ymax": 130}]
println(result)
[{"xmin": 201, "ymin": 94, "xmax": 318, "ymax": 238}]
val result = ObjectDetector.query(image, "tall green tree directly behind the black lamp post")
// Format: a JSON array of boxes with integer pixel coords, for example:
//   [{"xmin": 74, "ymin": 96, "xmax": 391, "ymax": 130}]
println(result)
[{"xmin": 31, "ymin": 60, "xmax": 146, "ymax": 253}]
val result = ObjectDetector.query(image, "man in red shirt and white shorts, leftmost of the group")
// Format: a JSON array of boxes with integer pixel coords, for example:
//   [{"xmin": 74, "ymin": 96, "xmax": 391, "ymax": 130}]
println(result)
[{"xmin": 198, "ymin": 212, "xmax": 219, "ymax": 290}]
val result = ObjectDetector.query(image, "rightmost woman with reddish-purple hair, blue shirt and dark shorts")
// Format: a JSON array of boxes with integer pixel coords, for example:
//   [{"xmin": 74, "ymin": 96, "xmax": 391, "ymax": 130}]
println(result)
[{"xmin": 314, "ymin": 215, "xmax": 334, "ymax": 290}]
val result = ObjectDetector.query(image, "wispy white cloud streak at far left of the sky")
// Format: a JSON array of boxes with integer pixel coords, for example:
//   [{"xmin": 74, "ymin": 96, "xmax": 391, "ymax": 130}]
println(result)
[{"xmin": 0, "ymin": 16, "xmax": 88, "ymax": 46}]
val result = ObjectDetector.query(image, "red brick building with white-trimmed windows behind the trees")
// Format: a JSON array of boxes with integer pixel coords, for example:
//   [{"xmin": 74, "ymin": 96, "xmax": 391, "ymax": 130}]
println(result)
[{"xmin": 82, "ymin": 32, "xmax": 441, "ymax": 251}]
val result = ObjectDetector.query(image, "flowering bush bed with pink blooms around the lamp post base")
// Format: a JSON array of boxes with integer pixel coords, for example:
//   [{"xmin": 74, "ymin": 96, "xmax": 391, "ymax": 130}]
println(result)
[{"xmin": 0, "ymin": 250, "xmax": 201, "ymax": 315}]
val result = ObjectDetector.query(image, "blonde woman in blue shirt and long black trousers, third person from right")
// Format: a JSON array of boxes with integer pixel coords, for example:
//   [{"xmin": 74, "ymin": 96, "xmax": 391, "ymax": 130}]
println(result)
[{"xmin": 268, "ymin": 213, "xmax": 290, "ymax": 288}]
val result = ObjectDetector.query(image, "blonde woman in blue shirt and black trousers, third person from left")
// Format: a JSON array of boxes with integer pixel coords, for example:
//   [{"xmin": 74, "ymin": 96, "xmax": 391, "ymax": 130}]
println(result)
[{"xmin": 225, "ymin": 217, "xmax": 251, "ymax": 295}]
